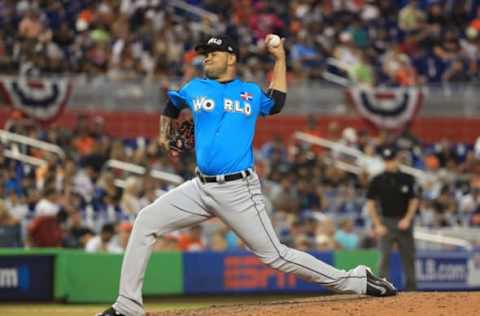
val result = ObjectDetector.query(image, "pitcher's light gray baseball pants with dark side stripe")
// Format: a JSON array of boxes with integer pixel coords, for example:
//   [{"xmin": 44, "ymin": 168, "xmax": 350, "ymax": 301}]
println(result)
[{"xmin": 113, "ymin": 173, "xmax": 366, "ymax": 316}]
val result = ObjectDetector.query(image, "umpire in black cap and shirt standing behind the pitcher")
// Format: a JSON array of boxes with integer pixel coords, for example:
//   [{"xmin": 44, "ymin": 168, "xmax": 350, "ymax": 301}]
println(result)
[{"xmin": 367, "ymin": 146, "xmax": 418, "ymax": 291}]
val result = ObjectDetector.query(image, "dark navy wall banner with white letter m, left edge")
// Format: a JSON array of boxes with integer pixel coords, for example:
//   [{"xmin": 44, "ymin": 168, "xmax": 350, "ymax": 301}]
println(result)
[{"xmin": 0, "ymin": 255, "xmax": 54, "ymax": 302}]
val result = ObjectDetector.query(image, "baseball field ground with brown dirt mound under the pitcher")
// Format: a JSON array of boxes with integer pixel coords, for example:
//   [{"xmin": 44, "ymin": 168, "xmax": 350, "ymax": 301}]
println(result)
[{"xmin": 0, "ymin": 292, "xmax": 480, "ymax": 316}]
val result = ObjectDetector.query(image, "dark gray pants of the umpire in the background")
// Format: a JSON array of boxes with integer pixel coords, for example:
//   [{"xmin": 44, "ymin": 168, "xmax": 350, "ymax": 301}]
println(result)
[{"xmin": 380, "ymin": 217, "xmax": 416, "ymax": 291}]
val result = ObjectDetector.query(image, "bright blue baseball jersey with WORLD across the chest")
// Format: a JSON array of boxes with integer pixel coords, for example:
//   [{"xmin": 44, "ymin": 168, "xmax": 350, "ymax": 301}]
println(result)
[{"xmin": 167, "ymin": 78, "xmax": 274, "ymax": 175}]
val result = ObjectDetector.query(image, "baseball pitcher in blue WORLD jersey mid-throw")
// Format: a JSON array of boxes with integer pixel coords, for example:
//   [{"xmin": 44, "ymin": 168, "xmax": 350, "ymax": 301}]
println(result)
[{"xmin": 98, "ymin": 34, "xmax": 396, "ymax": 316}]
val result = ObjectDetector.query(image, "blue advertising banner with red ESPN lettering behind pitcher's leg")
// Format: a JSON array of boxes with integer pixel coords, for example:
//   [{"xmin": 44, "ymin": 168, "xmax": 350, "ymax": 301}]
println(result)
[{"xmin": 183, "ymin": 252, "xmax": 333, "ymax": 294}]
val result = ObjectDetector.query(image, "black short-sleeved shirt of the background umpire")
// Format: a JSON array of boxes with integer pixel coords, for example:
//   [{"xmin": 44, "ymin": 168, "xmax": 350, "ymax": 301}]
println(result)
[{"xmin": 367, "ymin": 171, "xmax": 416, "ymax": 218}]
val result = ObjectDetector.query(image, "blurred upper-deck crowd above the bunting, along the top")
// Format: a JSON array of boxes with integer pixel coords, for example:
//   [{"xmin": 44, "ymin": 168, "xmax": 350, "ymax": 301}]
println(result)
[{"xmin": 0, "ymin": 0, "xmax": 480, "ymax": 86}]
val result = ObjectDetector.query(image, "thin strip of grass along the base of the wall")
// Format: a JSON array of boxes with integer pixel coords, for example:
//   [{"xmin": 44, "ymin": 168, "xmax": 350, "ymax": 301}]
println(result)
[{"xmin": 0, "ymin": 295, "xmax": 318, "ymax": 316}]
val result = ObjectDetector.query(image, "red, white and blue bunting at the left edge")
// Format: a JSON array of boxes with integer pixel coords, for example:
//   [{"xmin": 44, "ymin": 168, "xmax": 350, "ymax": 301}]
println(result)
[{"xmin": 0, "ymin": 78, "xmax": 72, "ymax": 123}]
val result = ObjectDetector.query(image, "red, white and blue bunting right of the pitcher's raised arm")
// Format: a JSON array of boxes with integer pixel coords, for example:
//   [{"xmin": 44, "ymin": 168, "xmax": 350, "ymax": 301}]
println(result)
[{"xmin": 347, "ymin": 87, "xmax": 423, "ymax": 129}]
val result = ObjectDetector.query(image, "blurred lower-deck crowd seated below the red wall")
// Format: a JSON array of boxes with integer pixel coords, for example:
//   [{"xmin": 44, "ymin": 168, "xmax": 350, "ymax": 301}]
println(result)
[{"xmin": 0, "ymin": 114, "xmax": 480, "ymax": 252}]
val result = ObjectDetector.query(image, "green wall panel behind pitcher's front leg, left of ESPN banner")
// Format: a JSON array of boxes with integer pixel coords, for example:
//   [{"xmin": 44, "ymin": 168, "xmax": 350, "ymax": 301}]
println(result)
[{"xmin": 55, "ymin": 250, "xmax": 183, "ymax": 303}]
